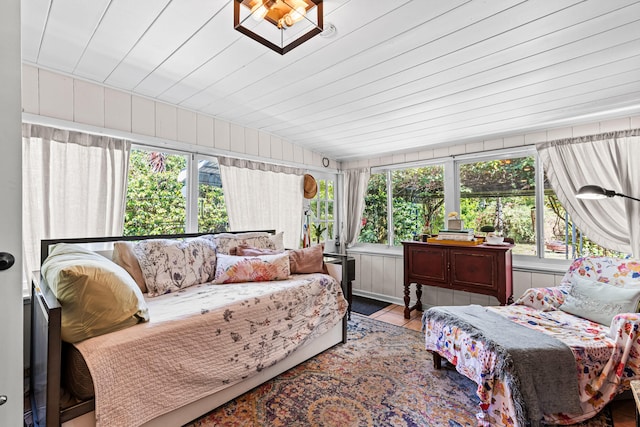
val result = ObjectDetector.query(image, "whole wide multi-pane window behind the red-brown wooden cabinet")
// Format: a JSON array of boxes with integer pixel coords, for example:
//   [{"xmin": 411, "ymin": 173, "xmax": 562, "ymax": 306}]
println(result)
[{"xmin": 359, "ymin": 147, "xmax": 624, "ymax": 260}]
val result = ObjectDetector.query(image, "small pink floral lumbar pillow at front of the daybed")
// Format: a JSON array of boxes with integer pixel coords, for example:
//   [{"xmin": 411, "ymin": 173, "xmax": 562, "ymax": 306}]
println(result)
[{"xmin": 213, "ymin": 253, "xmax": 290, "ymax": 284}]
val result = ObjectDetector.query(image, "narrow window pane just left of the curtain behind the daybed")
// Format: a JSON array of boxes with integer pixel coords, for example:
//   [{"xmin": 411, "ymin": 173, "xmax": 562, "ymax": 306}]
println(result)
[{"xmin": 198, "ymin": 160, "xmax": 229, "ymax": 233}]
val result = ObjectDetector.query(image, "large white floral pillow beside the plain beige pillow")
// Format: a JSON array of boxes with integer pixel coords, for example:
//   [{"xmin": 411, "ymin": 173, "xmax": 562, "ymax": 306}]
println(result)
[{"xmin": 133, "ymin": 238, "xmax": 216, "ymax": 296}]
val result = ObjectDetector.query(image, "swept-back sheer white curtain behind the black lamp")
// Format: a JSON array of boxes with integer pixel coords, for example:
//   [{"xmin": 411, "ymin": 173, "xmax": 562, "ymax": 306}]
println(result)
[{"xmin": 537, "ymin": 129, "xmax": 640, "ymax": 257}]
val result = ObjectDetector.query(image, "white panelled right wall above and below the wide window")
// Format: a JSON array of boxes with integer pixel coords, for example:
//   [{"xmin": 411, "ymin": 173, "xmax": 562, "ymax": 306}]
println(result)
[{"xmin": 342, "ymin": 116, "xmax": 640, "ymax": 305}]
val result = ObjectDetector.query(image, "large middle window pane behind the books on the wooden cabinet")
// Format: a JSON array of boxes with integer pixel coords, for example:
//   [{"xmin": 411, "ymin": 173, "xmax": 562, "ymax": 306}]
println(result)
[{"xmin": 460, "ymin": 156, "xmax": 537, "ymax": 255}]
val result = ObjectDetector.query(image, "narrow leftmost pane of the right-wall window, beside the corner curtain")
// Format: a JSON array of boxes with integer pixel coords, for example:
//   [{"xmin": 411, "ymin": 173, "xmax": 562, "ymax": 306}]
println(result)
[{"xmin": 358, "ymin": 173, "xmax": 389, "ymax": 244}]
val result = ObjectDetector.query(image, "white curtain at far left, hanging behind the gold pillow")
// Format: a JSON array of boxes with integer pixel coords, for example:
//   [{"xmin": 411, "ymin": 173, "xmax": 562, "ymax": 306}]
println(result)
[{"xmin": 22, "ymin": 124, "xmax": 131, "ymax": 277}]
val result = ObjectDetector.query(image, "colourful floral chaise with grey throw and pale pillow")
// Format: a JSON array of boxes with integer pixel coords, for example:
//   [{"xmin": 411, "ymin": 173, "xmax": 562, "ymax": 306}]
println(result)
[{"xmin": 423, "ymin": 257, "xmax": 640, "ymax": 427}]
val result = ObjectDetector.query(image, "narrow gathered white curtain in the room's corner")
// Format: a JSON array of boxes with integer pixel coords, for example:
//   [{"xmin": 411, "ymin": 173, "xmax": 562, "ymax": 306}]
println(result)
[{"xmin": 343, "ymin": 168, "xmax": 371, "ymax": 247}]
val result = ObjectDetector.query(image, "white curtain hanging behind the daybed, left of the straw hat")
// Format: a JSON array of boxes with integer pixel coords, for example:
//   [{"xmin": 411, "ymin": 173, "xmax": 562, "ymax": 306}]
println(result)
[{"xmin": 218, "ymin": 157, "xmax": 304, "ymax": 249}]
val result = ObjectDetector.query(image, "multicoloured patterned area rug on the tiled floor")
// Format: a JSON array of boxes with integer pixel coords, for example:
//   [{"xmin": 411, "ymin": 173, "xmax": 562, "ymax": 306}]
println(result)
[{"xmin": 188, "ymin": 313, "xmax": 613, "ymax": 427}]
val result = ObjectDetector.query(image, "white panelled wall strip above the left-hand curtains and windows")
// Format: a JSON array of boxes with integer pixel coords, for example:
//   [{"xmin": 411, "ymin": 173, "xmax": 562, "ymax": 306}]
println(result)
[{"xmin": 22, "ymin": 65, "xmax": 337, "ymax": 169}]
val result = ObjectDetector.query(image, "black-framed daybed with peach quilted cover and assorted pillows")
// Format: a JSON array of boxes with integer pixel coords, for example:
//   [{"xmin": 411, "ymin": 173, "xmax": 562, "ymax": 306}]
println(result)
[{"xmin": 31, "ymin": 232, "xmax": 347, "ymax": 427}]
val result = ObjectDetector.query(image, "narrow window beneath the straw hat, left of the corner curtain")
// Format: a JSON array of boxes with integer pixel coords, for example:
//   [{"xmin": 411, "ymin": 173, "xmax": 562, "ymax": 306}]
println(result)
[{"xmin": 309, "ymin": 174, "xmax": 336, "ymax": 242}]
